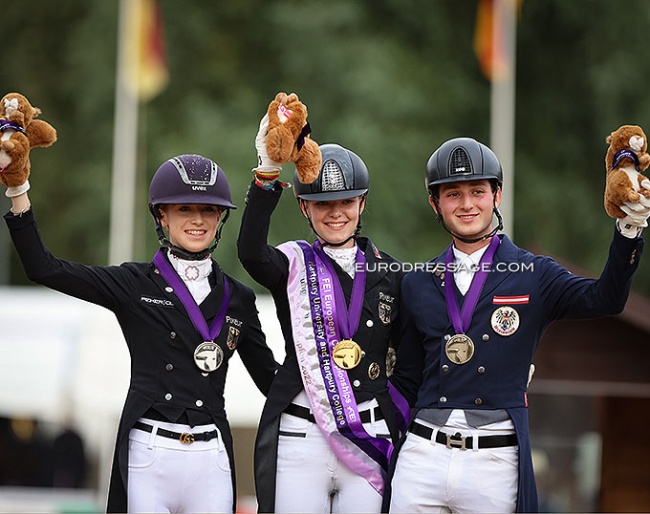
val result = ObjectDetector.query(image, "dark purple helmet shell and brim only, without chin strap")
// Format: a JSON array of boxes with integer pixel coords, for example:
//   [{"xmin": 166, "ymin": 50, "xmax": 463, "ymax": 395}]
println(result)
[{"xmin": 149, "ymin": 154, "xmax": 237, "ymax": 209}]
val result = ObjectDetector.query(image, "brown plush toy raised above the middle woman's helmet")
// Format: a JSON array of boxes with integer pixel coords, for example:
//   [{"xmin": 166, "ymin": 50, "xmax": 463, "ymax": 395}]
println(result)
[{"xmin": 255, "ymin": 92, "xmax": 322, "ymax": 184}]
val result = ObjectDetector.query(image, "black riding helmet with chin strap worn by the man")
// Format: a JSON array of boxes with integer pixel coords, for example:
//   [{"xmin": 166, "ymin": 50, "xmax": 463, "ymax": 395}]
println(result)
[{"xmin": 426, "ymin": 137, "xmax": 503, "ymax": 243}]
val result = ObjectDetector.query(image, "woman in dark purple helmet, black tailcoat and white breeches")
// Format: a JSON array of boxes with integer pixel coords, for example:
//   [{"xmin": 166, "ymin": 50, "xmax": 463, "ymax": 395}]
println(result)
[{"xmin": 5, "ymin": 155, "xmax": 276, "ymax": 512}]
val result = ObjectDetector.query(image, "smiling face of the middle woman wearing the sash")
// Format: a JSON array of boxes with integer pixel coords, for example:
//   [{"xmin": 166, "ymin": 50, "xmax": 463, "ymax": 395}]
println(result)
[{"xmin": 300, "ymin": 196, "xmax": 366, "ymax": 248}]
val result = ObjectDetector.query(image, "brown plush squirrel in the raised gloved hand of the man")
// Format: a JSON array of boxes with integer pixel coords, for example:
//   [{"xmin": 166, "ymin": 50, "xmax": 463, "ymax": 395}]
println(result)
[{"xmin": 604, "ymin": 125, "xmax": 650, "ymax": 237}]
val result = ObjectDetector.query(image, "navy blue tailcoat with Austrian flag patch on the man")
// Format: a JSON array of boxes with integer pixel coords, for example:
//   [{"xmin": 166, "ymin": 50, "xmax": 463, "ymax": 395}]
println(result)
[{"xmin": 391, "ymin": 231, "xmax": 643, "ymax": 512}]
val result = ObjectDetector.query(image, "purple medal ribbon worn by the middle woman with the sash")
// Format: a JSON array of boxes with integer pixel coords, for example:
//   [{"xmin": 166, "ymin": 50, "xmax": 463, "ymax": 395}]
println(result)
[{"xmin": 314, "ymin": 241, "xmax": 366, "ymax": 339}]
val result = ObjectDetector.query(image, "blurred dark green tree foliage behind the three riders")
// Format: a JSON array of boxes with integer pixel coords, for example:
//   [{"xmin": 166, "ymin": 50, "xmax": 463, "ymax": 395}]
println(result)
[{"xmin": 0, "ymin": 0, "xmax": 650, "ymax": 294}]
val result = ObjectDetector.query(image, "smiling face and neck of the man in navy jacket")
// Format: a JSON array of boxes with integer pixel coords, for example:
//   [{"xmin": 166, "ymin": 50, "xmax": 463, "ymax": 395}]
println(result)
[{"xmin": 429, "ymin": 180, "xmax": 501, "ymax": 253}]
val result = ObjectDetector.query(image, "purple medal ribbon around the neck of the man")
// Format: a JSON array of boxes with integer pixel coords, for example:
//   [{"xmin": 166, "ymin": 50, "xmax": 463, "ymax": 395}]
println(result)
[{"xmin": 445, "ymin": 236, "xmax": 501, "ymax": 334}]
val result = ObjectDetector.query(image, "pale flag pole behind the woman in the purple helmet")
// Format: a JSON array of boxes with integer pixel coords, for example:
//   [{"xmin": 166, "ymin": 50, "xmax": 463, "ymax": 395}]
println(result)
[{"xmin": 108, "ymin": 0, "xmax": 141, "ymax": 264}]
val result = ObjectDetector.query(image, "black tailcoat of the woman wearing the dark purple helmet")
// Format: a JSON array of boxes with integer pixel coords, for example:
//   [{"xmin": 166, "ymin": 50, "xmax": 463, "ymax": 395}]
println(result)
[{"xmin": 5, "ymin": 210, "xmax": 276, "ymax": 512}]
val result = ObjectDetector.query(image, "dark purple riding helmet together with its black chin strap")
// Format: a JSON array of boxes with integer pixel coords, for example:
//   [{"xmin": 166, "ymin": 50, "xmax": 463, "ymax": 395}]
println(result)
[{"xmin": 149, "ymin": 154, "xmax": 237, "ymax": 260}]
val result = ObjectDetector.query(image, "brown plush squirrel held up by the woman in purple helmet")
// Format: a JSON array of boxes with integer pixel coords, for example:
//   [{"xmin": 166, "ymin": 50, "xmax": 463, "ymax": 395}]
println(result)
[{"xmin": 0, "ymin": 93, "xmax": 56, "ymax": 197}]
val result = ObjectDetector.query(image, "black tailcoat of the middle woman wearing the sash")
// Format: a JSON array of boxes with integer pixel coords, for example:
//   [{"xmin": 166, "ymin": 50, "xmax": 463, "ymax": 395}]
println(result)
[{"xmin": 238, "ymin": 184, "xmax": 403, "ymax": 512}]
